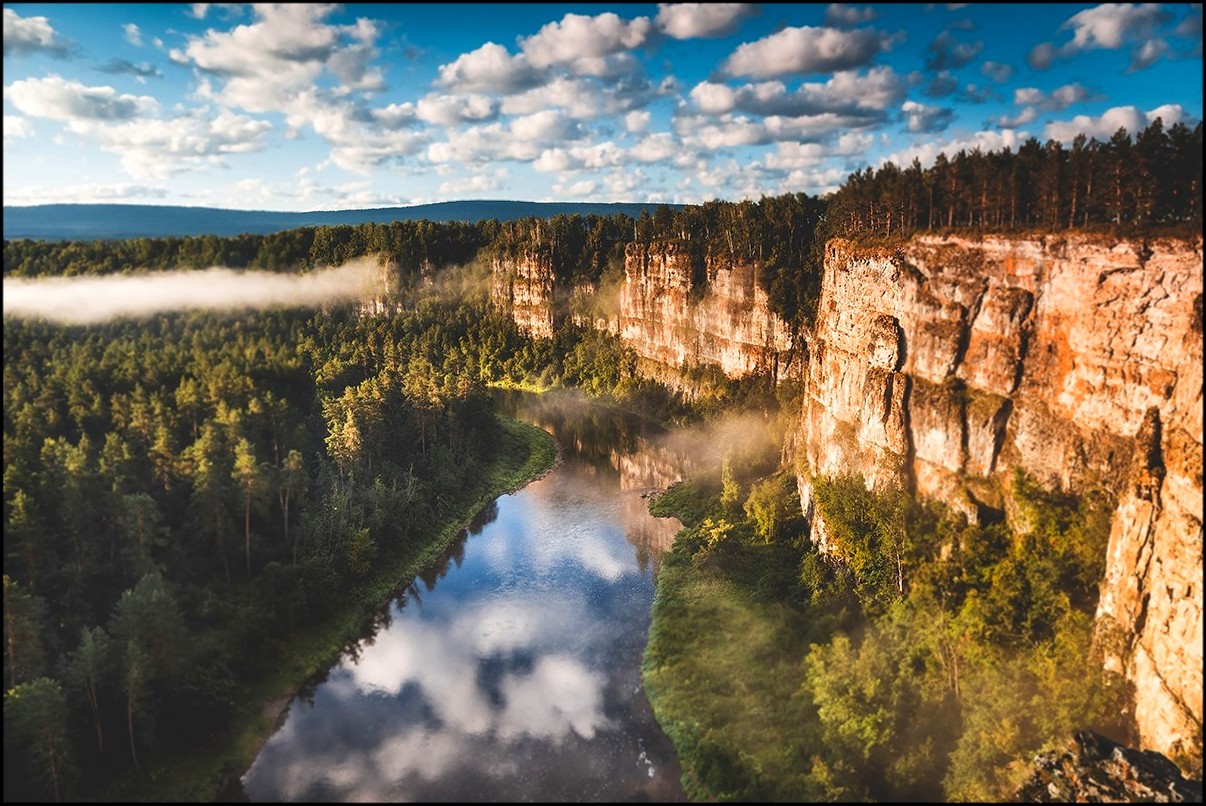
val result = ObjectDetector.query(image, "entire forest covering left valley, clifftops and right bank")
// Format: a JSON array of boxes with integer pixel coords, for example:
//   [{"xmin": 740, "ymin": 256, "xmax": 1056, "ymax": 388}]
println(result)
[{"xmin": 4, "ymin": 121, "xmax": 1202, "ymax": 800}]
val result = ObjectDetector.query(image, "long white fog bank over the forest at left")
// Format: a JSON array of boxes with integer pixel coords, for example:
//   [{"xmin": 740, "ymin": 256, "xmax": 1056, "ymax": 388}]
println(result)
[{"xmin": 4, "ymin": 257, "xmax": 381, "ymax": 325}]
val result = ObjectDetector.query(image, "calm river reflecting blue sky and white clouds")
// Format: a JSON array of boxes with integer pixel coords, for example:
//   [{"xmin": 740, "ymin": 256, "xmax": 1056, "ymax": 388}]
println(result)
[{"xmin": 242, "ymin": 395, "xmax": 684, "ymax": 801}]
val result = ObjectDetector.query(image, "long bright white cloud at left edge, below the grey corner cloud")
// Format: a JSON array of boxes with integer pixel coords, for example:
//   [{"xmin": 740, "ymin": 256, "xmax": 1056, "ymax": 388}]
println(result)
[{"xmin": 4, "ymin": 75, "xmax": 159, "ymax": 125}]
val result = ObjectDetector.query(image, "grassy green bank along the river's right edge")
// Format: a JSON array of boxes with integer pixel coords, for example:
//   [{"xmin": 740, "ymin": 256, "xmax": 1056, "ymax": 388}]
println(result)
[{"xmin": 642, "ymin": 483, "xmax": 815, "ymax": 801}]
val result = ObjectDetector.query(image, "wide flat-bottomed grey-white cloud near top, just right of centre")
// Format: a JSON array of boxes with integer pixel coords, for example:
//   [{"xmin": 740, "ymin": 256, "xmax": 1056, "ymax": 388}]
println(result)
[{"xmin": 722, "ymin": 25, "xmax": 889, "ymax": 78}]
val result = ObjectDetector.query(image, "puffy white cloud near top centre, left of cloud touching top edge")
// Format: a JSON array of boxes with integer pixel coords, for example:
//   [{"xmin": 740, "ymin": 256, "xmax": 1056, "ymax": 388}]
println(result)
[{"xmin": 520, "ymin": 12, "xmax": 654, "ymax": 75}]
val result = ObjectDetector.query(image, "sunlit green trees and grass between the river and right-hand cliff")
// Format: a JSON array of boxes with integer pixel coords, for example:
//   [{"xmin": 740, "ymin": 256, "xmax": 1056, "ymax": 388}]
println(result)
[{"xmin": 644, "ymin": 463, "xmax": 1123, "ymax": 801}]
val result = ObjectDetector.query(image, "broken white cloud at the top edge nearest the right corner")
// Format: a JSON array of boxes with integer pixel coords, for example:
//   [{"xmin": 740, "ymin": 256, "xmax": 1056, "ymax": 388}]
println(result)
[{"xmin": 1026, "ymin": 2, "xmax": 1170, "ymax": 72}]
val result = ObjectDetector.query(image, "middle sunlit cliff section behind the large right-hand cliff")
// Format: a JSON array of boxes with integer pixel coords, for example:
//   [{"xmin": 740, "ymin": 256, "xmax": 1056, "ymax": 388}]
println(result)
[{"xmin": 617, "ymin": 241, "xmax": 791, "ymax": 378}]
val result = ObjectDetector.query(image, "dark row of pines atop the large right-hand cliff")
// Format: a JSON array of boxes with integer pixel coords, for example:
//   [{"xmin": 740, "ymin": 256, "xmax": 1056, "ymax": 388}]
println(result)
[{"xmin": 826, "ymin": 118, "xmax": 1202, "ymax": 238}]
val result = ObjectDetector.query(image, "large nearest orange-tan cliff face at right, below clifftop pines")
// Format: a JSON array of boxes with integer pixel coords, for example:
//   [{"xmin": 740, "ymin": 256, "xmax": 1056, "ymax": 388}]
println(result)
[{"xmin": 796, "ymin": 234, "xmax": 1202, "ymax": 765}]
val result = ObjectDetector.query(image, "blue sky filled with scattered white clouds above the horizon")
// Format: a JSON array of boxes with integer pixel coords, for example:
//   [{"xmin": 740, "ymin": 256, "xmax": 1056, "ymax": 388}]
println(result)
[{"xmin": 4, "ymin": 2, "xmax": 1202, "ymax": 211}]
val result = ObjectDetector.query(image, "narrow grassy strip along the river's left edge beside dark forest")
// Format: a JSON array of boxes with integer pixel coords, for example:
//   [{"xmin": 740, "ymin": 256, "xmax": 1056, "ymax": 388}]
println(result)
[{"xmin": 113, "ymin": 416, "xmax": 557, "ymax": 802}]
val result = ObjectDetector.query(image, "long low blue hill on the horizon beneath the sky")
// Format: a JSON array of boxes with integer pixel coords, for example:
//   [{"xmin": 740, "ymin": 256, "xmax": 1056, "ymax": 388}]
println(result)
[{"xmin": 4, "ymin": 200, "xmax": 683, "ymax": 240}]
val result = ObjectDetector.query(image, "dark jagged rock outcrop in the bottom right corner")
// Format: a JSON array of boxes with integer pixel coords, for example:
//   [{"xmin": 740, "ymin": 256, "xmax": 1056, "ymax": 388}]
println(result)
[{"xmin": 1014, "ymin": 731, "xmax": 1202, "ymax": 804}]
